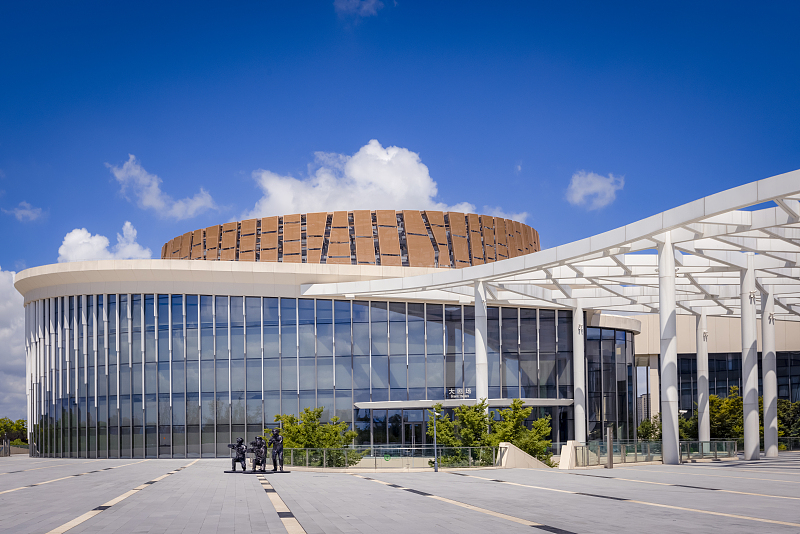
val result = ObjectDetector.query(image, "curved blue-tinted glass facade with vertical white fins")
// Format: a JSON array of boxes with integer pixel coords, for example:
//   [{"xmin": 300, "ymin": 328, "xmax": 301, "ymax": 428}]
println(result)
[{"xmin": 26, "ymin": 294, "xmax": 635, "ymax": 458}]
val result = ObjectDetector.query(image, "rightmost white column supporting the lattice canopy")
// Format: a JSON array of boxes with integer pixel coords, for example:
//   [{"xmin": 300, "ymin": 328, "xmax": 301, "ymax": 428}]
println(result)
[{"xmin": 761, "ymin": 286, "xmax": 778, "ymax": 458}]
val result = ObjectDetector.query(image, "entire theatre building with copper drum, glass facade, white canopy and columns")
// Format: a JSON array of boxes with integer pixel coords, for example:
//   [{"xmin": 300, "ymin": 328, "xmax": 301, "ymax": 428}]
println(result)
[{"xmin": 15, "ymin": 171, "xmax": 800, "ymax": 463}]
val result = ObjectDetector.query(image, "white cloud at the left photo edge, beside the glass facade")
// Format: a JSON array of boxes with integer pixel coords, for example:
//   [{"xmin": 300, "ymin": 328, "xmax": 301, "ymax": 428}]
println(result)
[{"xmin": 0, "ymin": 270, "xmax": 27, "ymax": 419}]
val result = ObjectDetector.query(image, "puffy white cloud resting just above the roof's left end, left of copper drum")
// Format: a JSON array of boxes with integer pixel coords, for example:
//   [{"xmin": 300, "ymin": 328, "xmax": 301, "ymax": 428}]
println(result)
[{"xmin": 58, "ymin": 221, "xmax": 152, "ymax": 263}]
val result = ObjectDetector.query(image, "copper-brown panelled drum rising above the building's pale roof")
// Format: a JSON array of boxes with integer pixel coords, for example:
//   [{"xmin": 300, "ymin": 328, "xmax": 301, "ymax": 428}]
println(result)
[{"xmin": 161, "ymin": 210, "xmax": 540, "ymax": 269}]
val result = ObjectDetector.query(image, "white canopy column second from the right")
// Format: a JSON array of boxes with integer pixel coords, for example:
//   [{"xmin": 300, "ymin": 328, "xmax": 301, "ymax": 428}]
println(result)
[{"xmin": 740, "ymin": 252, "xmax": 761, "ymax": 460}]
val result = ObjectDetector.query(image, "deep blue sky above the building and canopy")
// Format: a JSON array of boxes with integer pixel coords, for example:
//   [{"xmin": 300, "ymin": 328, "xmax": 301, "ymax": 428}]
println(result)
[{"xmin": 0, "ymin": 0, "xmax": 800, "ymax": 418}]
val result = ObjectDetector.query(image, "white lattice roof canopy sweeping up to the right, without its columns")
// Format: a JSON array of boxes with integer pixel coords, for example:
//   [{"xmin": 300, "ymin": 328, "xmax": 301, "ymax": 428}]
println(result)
[{"xmin": 301, "ymin": 170, "xmax": 800, "ymax": 321}]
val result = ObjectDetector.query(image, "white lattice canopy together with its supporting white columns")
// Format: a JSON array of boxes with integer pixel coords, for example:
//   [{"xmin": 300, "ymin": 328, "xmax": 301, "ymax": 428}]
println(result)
[{"xmin": 302, "ymin": 170, "xmax": 800, "ymax": 463}]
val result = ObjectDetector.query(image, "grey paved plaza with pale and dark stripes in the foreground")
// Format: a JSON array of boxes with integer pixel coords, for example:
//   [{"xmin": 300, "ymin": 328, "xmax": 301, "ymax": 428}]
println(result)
[{"xmin": 0, "ymin": 453, "xmax": 800, "ymax": 534}]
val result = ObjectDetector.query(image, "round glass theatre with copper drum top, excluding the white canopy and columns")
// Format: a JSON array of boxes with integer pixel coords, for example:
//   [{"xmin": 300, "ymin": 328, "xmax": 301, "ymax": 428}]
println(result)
[{"xmin": 17, "ymin": 211, "xmax": 638, "ymax": 457}]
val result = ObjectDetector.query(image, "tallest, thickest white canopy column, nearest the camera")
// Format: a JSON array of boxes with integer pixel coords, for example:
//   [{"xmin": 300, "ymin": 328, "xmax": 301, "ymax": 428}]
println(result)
[{"xmin": 658, "ymin": 232, "xmax": 680, "ymax": 465}]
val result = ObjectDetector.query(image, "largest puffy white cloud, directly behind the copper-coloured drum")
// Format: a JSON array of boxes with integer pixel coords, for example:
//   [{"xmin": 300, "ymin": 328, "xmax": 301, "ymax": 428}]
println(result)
[{"xmin": 242, "ymin": 139, "xmax": 475, "ymax": 219}]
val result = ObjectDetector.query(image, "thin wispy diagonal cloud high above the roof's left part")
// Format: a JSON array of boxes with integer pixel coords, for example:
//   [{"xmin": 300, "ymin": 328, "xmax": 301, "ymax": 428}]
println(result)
[{"xmin": 106, "ymin": 154, "xmax": 217, "ymax": 220}]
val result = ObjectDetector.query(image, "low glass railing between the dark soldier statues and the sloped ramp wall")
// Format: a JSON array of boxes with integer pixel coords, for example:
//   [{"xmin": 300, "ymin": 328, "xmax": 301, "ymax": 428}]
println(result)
[{"xmin": 278, "ymin": 445, "xmax": 498, "ymax": 469}]
